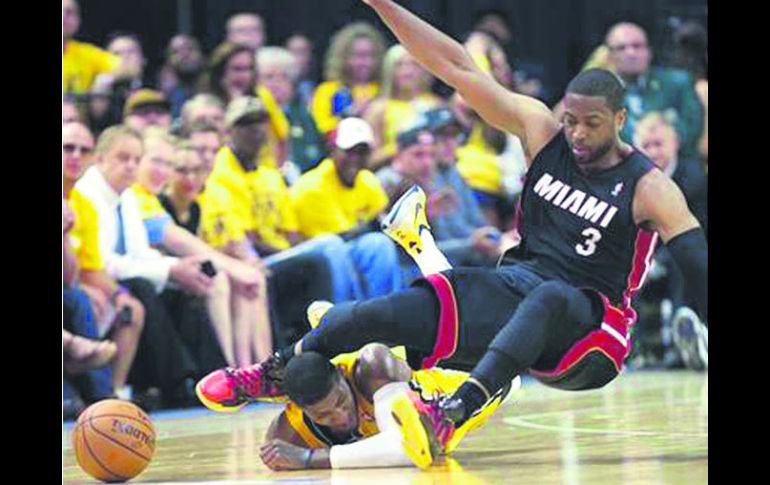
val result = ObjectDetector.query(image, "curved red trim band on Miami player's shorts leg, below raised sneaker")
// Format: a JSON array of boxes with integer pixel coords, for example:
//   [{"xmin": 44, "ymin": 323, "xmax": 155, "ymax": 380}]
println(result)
[{"xmin": 422, "ymin": 273, "xmax": 460, "ymax": 369}]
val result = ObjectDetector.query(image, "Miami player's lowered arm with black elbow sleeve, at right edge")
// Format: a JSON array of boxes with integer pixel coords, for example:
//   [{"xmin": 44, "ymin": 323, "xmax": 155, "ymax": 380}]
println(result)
[{"xmin": 633, "ymin": 170, "xmax": 708, "ymax": 320}]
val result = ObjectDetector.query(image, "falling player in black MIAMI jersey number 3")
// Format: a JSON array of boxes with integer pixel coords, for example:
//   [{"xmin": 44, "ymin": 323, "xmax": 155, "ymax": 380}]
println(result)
[{"xmin": 199, "ymin": 0, "xmax": 708, "ymax": 466}]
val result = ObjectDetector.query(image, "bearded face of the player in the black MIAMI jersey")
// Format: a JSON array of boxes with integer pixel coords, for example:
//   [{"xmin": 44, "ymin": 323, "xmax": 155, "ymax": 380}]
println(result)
[{"xmin": 562, "ymin": 93, "xmax": 625, "ymax": 165}]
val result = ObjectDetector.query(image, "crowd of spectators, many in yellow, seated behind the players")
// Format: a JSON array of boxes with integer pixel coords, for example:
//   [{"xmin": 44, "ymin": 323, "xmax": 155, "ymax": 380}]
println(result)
[{"xmin": 62, "ymin": 0, "xmax": 708, "ymax": 416}]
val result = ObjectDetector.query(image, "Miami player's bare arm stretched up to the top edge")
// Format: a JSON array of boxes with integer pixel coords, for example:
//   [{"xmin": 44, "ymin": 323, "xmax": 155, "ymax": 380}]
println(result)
[{"xmin": 362, "ymin": 0, "xmax": 559, "ymax": 162}]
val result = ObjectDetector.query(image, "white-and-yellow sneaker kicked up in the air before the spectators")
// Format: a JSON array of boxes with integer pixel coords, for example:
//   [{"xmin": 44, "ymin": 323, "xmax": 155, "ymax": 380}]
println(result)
[{"xmin": 381, "ymin": 185, "xmax": 430, "ymax": 258}]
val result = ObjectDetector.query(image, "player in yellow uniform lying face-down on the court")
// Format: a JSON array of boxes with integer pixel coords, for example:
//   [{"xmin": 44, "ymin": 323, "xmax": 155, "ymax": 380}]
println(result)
[{"xmin": 260, "ymin": 343, "xmax": 520, "ymax": 470}]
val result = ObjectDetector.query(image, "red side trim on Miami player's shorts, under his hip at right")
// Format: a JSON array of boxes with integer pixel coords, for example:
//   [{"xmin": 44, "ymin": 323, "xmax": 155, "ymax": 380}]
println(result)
[{"xmin": 529, "ymin": 292, "xmax": 636, "ymax": 378}]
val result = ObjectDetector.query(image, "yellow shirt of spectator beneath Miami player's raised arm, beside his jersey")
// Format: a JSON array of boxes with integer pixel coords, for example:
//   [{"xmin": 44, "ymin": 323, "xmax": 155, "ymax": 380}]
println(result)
[{"xmin": 457, "ymin": 123, "xmax": 503, "ymax": 194}]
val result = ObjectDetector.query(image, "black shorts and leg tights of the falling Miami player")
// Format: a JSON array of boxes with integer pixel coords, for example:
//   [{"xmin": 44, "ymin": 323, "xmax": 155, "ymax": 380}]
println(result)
[{"xmin": 303, "ymin": 267, "xmax": 603, "ymax": 374}]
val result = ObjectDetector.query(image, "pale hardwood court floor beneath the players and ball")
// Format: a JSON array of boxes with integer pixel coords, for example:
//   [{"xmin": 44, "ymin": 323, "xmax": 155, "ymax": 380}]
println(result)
[{"xmin": 62, "ymin": 371, "xmax": 708, "ymax": 485}]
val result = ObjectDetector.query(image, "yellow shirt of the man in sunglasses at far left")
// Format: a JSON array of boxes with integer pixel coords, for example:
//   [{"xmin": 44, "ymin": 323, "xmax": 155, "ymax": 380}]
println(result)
[{"xmin": 67, "ymin": 189, "xmax": 104, "ymax": 271}]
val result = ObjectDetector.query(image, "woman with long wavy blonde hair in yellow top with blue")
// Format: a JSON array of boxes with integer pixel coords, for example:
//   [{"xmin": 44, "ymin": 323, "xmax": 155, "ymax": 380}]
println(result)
[{"xmin": 311, "ymin": 22, "xmax": 385, "ymax": 135}]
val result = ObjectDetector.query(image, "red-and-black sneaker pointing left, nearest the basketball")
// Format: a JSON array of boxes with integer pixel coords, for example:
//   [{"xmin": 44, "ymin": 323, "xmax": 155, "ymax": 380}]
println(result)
[{"xmin": 195, "ymin": 354, "xmax": 284, "ymax": 412}]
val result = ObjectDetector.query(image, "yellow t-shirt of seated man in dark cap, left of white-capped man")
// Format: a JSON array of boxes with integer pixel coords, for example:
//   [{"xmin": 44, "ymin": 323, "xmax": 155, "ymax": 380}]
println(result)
[{"xmin": 206, "ymin": 146, "xmax": 297, "ymax": 250}]
